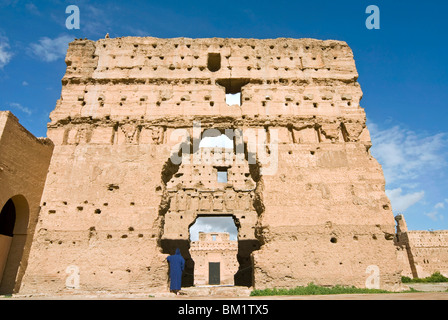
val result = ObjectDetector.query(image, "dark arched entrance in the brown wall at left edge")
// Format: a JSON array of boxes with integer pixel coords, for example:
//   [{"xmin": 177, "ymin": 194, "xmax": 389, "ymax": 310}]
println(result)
[{"xmin": 0, "ymin": 195, "xmax": 29, "ymax": 294}]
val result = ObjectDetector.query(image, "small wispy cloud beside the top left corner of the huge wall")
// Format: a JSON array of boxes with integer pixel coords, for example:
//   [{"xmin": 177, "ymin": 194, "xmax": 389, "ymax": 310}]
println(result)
[{"xmin": 29, "ymin": 35, "xmax": 74, "ymax": 62}]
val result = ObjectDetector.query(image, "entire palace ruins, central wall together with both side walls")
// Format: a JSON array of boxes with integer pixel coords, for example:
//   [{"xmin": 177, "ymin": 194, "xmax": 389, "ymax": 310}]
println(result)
[{"xmin": 0, "ymin": 36, "xmax": 448, "ymax": 294}]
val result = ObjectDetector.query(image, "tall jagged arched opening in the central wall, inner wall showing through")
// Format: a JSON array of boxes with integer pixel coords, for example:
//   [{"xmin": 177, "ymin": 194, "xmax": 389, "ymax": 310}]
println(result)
[{"xmin": 158, "ymin": 128, "xmax": 264, "ymax": 287}]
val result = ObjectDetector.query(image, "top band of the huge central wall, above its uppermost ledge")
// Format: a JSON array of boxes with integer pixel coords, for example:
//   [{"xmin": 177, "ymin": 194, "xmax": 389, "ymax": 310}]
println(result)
[{"xmin": 64, "ymin": 37, "xmax": 358, "ymax": 81}]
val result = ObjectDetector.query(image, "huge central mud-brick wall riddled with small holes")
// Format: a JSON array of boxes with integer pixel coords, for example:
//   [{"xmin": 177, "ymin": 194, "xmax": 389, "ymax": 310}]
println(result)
[{"xmin": 22, "ymin": 37, "xmax": 399, "ymax": 292}]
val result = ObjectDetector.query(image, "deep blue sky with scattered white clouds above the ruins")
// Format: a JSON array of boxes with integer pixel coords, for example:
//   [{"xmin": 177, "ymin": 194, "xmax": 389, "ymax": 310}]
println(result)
[{"xmin": 0, "ymin": 0, "xmax": 448, "ymax": 230}]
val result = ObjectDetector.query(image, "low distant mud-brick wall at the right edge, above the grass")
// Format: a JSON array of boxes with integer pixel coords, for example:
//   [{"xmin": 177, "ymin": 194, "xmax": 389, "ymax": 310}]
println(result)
[{"xmin": 395, "ymin": 215, "xmax": 448, "ymax": 278}]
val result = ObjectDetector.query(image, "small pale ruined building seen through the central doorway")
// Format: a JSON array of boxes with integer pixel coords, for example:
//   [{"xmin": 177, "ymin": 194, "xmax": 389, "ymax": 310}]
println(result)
[{"xmin": 190, "ymin": 232, "xmax": 238, "ymax": 285}]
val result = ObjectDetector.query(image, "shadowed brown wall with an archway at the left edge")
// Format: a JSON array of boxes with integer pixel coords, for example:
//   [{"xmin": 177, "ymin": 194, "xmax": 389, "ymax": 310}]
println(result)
[{"xmin": 0, "ymin": 111, "xmax": 53, "ymax": 294}]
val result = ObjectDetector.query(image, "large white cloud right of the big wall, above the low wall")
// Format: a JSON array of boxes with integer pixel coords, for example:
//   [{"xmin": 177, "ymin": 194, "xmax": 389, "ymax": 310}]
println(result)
[{"xmin": 368, "ymin": 122, "xmax": 448, "ymax": 220}]
